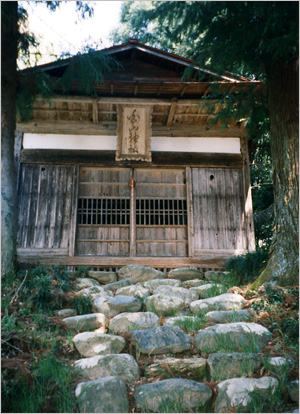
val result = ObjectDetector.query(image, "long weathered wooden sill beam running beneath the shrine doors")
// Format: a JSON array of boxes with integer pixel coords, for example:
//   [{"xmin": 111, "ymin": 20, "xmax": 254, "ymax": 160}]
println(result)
[{"xmin": 18, "ymin": 255, "xmax": 228, "ymax": 269}]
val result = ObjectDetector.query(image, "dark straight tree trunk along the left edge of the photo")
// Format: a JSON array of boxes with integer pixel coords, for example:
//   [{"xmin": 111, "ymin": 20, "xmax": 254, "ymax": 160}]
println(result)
[{"xmin": 1, "ymin": 1, "xmax": 18, "ymax": 274}]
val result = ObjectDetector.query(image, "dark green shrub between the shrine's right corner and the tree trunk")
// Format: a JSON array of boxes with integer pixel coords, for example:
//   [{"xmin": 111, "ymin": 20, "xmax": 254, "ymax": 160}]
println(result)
[{"xmin": 225, "ymin": 249, "xmax": 268, "ymax": 285}]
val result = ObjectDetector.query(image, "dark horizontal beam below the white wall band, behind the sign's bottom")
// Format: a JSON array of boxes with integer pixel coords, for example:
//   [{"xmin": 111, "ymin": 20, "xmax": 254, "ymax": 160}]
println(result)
[{"xmin": 21, "ymin": 149, "xmax": 243, "ymax": 168}]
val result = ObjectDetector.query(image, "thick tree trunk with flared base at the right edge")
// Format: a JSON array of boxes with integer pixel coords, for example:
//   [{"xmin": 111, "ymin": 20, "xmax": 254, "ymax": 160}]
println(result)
[{"xmin": 252, "ymin": 61, "xmax": 299, "ymax": 287}]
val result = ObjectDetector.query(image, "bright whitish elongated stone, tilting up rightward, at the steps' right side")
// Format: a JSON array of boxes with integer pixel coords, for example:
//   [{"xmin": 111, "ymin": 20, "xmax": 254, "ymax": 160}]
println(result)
[{"xmin": 189, "ymin": 293, "xmax": 246, "ymax": 313}]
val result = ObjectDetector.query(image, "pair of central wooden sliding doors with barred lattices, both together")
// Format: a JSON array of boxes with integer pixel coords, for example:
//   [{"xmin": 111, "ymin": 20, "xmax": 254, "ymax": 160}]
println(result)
[{"xmin": 76, "ymin": 168, "xmax": 188, "ymax": 257}]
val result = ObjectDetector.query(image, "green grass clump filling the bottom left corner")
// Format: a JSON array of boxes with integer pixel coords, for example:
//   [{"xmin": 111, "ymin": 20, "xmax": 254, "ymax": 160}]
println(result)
[{"xmin": 1, "ymin": 355, "xmax": 78, "ymax": 413}]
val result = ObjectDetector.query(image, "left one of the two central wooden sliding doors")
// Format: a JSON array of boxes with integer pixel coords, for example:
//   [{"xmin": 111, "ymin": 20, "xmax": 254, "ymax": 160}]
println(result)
[{"xmin": 75, "ymin": 168, "xmax": 130, "ymax": 256}]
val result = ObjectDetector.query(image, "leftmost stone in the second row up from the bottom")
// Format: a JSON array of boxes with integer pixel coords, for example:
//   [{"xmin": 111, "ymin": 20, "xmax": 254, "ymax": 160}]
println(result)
[{"xmin": 75, "ymin": 354, "xmax": 140, "ymax": 382}]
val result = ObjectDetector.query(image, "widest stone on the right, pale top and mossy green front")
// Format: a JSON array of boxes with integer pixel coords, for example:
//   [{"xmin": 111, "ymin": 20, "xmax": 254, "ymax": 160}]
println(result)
[{"xmin": 195, "ymin": 322, "xmax": 272, "ymax": 353}]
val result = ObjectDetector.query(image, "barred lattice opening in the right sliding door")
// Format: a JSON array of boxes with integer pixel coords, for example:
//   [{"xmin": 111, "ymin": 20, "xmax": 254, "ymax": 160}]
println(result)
[{"xmin": 136, "ymin": 199, "xmax": 187, "ymax": 226}]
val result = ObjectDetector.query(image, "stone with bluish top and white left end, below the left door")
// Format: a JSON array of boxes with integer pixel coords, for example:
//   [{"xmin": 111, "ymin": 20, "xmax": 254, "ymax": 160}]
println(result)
[{"xmin": 94, "ymin": 295, "xmax": 142, "ymax": 318}]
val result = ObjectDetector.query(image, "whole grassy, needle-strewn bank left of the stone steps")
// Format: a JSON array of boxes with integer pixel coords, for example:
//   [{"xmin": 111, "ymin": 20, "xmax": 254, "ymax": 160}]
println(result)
[{"xmin": 1, "ymin": 266, "xmax": 84, "ymax": 413}]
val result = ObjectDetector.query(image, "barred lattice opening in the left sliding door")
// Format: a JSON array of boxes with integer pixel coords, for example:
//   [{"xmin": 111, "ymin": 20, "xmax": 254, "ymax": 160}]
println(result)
[{"xmin": 77, "ymin": 198, "xmax": 130, "ymax": 226}]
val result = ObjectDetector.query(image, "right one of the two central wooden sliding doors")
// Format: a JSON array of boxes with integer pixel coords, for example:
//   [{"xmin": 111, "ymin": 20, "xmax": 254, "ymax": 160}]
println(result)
[{"xmin": 135, "ymin": 169, "xmax": 188, "ymax": 257}]
